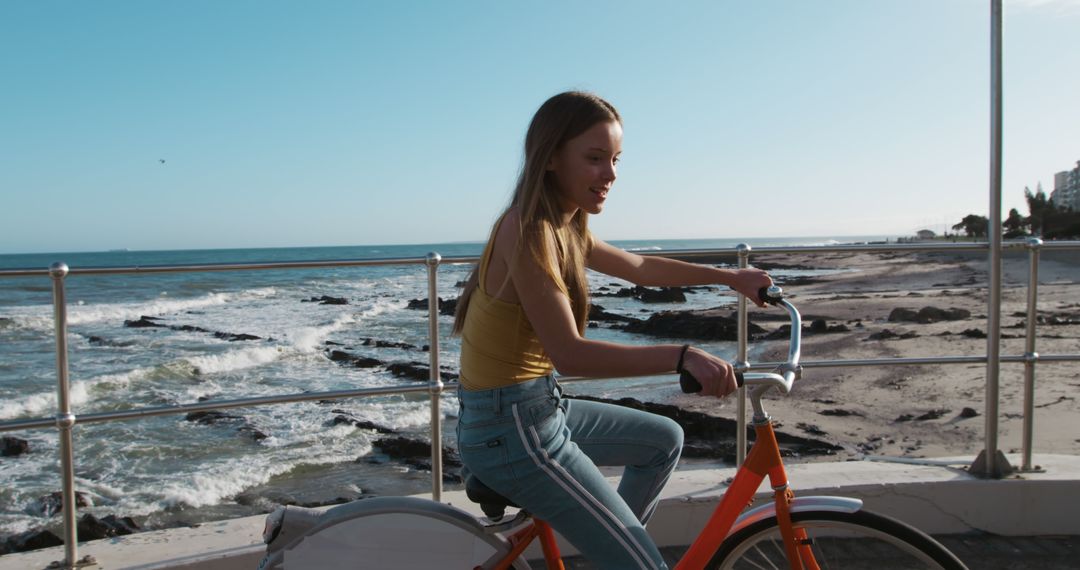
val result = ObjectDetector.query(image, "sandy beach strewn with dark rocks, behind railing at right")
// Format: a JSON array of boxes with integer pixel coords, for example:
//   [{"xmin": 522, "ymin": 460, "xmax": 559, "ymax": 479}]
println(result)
[{"xmin": 676, "ymin": 250, "xmax": 1080, "ymax": 460}]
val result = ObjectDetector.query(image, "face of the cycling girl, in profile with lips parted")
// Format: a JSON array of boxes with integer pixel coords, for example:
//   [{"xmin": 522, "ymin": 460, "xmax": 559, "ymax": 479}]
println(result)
[{"xmin": 548, "ymin": 121, "xmax": 622, "ymax": 216}]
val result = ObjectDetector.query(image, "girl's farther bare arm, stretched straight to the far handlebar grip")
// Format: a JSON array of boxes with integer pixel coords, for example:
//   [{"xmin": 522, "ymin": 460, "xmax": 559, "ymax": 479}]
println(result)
[{"xmin": 589, "ymin": 239, "xmax": 772, "ymax": 306}]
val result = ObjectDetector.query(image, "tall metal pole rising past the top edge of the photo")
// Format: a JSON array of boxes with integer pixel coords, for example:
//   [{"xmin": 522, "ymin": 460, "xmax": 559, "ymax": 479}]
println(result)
[{"xmin": 971, "ymin": 0, "xmax": 1013, "ymax": 478}]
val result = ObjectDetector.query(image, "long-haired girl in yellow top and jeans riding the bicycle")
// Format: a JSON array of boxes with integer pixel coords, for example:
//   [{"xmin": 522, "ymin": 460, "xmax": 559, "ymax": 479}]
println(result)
[{"xmin": 455, "ymin": 92, "xmax": 771, "ymax": 569}]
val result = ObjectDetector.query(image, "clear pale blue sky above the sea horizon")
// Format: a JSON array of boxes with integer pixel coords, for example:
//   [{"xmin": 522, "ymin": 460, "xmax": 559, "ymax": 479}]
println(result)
[{"xmin": 0, "ymin": 0, "xmax": 1080, "ymax": 253}]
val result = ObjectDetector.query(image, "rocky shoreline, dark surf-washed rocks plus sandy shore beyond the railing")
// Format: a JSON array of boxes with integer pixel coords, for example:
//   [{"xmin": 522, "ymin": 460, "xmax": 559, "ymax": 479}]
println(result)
[{"xmin": 0, "ymin": 248, "xmax": 1080, "ymax": 554}]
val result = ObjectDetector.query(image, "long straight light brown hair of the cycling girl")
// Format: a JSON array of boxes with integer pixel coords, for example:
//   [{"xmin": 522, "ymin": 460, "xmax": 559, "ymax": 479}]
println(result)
[{"xmin": 454, "ymin": 91, "xmax": 622, "ymax": 334}]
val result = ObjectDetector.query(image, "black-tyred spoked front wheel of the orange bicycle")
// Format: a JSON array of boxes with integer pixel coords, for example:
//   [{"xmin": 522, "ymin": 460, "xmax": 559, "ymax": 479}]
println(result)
[{"xmin": 707, "ymin": 511, "xmax": 967, "ymax": 570}]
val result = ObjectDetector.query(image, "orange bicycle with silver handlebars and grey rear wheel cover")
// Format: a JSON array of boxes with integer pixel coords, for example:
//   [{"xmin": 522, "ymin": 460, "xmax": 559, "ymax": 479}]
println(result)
[{"xmin": 259, "ymin": 287, "xmax": 966, "ymax": 570}]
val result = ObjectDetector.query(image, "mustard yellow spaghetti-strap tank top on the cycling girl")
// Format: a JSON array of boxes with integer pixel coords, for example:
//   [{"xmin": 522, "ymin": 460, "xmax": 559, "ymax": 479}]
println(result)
[{"xmin": 461, "ymin": 239, "xmax": 555, "ymax": 390}]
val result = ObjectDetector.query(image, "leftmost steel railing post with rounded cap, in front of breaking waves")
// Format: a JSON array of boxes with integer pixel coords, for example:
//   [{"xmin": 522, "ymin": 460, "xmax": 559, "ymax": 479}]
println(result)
[{"xmin": 49, "ymin": 261, "xmax": 79, "ymax": 568}]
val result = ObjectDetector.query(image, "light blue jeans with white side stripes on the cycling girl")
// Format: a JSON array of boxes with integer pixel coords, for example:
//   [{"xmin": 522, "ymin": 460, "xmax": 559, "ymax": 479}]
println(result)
[{"xmin": 457, "ymin": 376, "xmax": 683, "ymax": 570}]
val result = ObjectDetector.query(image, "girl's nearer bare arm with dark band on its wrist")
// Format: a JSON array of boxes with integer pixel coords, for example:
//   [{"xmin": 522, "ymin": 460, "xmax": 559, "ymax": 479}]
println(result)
[{"xmin": 496, "ymin": 225, "xmax": 735, "ymax": 396}]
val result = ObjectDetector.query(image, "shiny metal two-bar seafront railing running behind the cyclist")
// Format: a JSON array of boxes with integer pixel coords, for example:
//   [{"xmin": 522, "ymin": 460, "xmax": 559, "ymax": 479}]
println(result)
[{"xmin": 0, "ymin": 239, "xmax": 1080, "ymax": 568}]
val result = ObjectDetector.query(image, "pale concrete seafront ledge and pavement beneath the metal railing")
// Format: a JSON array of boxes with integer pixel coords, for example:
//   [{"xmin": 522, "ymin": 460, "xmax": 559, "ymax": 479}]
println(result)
[{"xmin": 0, "ymin": 454, "xmax": 1080, "ymax": 570}]
